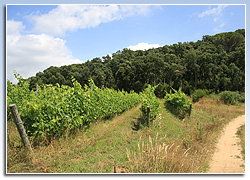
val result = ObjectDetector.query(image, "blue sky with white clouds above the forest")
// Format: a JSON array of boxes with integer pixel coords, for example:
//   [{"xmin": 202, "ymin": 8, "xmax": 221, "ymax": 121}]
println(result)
[{"xmin": 6, "ymin": 4, "xmax": 245, "ymax": 83}]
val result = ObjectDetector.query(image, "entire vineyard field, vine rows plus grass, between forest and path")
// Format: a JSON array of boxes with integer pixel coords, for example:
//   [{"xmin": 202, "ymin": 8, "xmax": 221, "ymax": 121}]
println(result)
[{"xmin": 7, "ymin": 74, "xmax": 244, "ymax": 173}]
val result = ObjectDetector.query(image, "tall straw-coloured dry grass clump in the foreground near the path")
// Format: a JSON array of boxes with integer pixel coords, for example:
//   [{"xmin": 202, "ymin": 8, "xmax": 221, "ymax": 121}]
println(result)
[{"xmin": 127, "ymin": 136, "xmax": 204, "ymax": 173}]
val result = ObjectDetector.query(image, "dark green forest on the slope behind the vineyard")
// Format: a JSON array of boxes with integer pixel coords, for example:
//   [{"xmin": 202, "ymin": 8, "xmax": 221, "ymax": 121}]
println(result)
[{"xmin": 28, "ymin": 29, "xmax": 245, "ymax": 96}]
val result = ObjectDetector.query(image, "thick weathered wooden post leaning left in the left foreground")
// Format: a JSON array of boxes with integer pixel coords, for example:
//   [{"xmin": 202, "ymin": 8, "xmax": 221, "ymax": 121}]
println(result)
[{"xmin": 9, "ymin": 104, "xmax": 33, "ymax": 153}]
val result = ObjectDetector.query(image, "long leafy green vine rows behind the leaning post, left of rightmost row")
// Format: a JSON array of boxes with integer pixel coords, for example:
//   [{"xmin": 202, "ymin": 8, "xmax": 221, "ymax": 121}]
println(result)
[{"xmin": 7, "ymin": 73, "xmax": 159, "ymax": 141}]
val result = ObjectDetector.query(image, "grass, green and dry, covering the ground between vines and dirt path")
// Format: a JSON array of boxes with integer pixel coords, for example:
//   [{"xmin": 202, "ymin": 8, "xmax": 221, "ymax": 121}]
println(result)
[{"xmin": 7, "ymin": 98, "xmax": 244, "ymax": 173}]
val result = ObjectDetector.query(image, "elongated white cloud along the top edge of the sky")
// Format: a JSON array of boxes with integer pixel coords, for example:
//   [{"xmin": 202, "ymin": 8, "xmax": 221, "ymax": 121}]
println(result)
[{"xmin": 29, "ymin": 5, "xmax": 150, "ymax": 36}]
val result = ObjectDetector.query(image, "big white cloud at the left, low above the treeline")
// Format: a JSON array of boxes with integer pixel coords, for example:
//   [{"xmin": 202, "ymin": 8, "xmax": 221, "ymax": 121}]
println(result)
[{"xmin": 6, "ymin": 21, "xmax": 82, "ymax": 82}]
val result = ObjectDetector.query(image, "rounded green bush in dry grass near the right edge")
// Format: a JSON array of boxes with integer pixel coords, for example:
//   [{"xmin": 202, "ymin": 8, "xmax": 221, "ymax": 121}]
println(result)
[{"xmin": 219, "ymin": 91, "xmax": 241, "ymax": 105}]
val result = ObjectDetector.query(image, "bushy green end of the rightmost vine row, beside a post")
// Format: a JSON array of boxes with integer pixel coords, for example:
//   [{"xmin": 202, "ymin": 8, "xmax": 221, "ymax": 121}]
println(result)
[{"xmin": 165, "ymin": 88, "xmax": 191, "ymax": 119}]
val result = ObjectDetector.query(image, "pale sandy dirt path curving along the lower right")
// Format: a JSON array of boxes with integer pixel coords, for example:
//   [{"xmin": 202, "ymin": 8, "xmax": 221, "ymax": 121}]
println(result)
[{"xmin": 208, "ymin": 115, "xmax": 245, "ymax": 173}]
